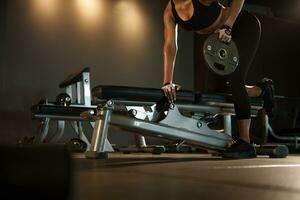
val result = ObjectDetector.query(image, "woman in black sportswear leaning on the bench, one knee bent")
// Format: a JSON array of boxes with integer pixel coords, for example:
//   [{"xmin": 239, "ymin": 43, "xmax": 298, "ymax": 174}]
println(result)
[{"xmin": 162, "ymin": 0, "xmax": 274, "ymax": 158}]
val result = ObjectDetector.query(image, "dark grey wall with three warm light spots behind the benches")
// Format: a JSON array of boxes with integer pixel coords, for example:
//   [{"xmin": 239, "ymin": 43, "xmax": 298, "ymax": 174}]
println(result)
[{"xmin": 0, "ymin": 0, "xmax": 193, "ymax": 142}]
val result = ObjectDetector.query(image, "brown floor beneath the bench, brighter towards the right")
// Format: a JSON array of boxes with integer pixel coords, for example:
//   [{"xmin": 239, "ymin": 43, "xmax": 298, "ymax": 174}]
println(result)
[{"xmin": 71, "ymin": 153, "xmax": 300, "ymax": 200}]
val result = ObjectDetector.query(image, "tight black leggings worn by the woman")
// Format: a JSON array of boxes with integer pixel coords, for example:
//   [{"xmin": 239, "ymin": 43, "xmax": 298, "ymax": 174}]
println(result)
[{"xmin": 224, "ymin": 11, "xmax": 261, "ymax": 120}]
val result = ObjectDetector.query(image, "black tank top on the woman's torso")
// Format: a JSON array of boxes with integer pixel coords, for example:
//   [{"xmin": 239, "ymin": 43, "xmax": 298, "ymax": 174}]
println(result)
[{"xmin": 171, "ymin": 0, "xmax": 221, "ymax": 31}]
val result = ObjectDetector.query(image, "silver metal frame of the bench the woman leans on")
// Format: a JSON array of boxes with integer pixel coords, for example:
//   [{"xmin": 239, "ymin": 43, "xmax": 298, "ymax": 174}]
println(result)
[{"xmin": 86, "ymin": 99, "xmax": 261, "ymax": 158}]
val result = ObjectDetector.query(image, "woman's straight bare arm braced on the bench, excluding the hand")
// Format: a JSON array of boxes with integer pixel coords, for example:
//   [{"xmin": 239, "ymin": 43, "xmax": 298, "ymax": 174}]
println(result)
[{"xmin": 163, "ymin": 2, "xmax": 178, "ymax": 84}]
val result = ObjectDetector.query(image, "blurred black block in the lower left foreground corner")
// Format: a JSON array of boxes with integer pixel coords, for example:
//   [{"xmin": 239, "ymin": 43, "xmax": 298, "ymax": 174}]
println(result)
[{"xmin": 0, "ymin": 145, "xmax": 72, "ymax": 200}]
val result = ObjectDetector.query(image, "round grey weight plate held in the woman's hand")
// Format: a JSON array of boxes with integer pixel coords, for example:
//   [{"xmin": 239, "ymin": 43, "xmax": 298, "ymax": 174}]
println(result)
[{"xmin": 203, "ymin": 33, "xmax": 239, "ymax": 76}]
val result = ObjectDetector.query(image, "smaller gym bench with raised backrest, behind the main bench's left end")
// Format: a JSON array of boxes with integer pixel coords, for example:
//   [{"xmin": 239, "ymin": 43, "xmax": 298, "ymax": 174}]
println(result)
[{"xmin": 31, "ymin": 68, "xmax": 96, "ymax": 149}]
